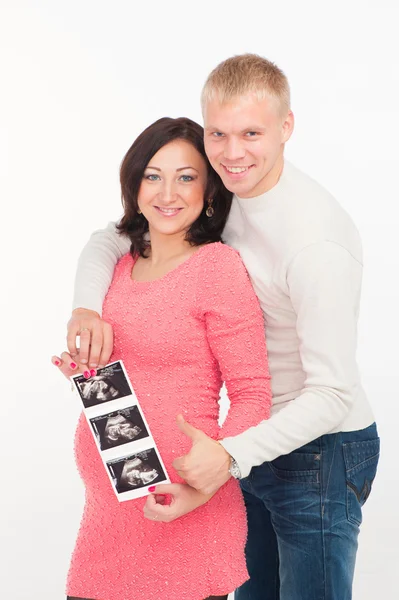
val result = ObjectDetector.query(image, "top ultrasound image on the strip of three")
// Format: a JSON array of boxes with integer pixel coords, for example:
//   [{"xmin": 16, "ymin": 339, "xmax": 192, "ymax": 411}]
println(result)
[{"xmin": 72, "ymin": 361, "xmax": 132, "ymax": 408}]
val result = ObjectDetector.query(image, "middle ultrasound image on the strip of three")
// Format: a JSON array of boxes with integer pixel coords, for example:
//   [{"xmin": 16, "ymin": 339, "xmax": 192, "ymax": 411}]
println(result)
[{"xmin": 90, "ymin": 404, "xmax": 149, "ymax": 450}]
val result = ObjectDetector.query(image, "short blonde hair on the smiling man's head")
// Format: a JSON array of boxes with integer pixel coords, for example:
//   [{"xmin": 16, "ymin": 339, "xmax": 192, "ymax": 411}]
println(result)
[{"xmin": 201, "ymin": 54, "xmax": 290, "ymax": 114}]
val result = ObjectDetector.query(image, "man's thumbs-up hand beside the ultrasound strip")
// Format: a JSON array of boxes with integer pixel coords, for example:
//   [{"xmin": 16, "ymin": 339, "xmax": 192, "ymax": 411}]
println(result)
[{"xmin": 173, "ymin": 415, "xmax": 231, "ymax": 494}]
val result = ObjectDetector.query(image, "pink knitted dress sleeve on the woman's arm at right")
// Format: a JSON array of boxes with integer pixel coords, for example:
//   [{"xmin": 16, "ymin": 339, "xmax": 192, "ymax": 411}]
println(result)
[{"xmin": 199, "ymin": 246, "xmax": 271, "ymax": 437}]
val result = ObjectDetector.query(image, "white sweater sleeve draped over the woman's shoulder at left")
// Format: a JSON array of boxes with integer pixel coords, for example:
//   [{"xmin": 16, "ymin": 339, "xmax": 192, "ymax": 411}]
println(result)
[{"xmin": 72, "ymin": 222, "xmax": 130, "ymax": 315}]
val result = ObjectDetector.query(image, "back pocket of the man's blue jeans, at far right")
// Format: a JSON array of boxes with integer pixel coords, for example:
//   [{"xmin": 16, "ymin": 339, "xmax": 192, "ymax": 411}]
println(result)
[{"xmin": 342, "ymin": 438, "xmax": 380, "ymax": 525}]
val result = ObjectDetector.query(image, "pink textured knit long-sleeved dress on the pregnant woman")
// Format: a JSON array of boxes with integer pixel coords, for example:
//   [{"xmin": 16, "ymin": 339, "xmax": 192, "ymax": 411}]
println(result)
[{"xmin": 67, "ymin": 243, "xmax": 271, "ymax": 600}]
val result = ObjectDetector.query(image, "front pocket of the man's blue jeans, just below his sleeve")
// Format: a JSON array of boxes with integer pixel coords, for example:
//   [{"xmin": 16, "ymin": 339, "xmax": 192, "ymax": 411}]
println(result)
[{"xmin": 267, "ymin": 452, "xmax": 320, "ymax": 484}]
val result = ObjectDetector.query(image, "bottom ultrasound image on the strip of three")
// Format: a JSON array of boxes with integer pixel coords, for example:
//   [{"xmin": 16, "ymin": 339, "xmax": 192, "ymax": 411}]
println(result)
[{"xmin": 107, "ymin": 448, "xmax": 167, "ymax": 499}]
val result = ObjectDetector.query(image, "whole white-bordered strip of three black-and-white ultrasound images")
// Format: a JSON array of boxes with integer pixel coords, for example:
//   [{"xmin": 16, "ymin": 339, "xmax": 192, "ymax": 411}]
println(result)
[{"xmin": 71, "ymin": 360, "xmax": 170, "ymax": 502}]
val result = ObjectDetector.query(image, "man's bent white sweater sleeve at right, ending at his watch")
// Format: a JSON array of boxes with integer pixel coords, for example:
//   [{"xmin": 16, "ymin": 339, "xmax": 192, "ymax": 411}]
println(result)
[{"xmin": 222, "ymin": 242, "xmax": 362, "ymax": 476}]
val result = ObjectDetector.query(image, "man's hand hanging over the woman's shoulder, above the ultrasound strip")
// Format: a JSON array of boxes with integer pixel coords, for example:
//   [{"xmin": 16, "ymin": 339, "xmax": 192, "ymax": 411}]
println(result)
[{"xmin": 67, "ymin": 308, "xmax": 114, "ymax": 369}]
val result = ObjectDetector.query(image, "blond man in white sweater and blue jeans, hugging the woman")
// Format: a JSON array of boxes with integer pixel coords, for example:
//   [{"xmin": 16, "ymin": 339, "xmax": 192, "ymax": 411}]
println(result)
[{"xmin": 68, "ymin": 54, "xmax": 379, "ymax": 600}]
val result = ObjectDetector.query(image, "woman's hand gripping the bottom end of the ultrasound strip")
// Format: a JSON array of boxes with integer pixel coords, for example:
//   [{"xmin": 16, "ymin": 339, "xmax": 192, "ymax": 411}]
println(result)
[{"xmin": 144, "ymin": 483, "xmax": 214, "ymax": 523}]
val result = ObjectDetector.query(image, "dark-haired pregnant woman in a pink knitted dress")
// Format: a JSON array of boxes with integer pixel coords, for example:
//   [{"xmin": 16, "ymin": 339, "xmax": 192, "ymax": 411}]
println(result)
[{"xmin": 53, "ymin": 118, "xmax": 271, "ymax": 600}]
